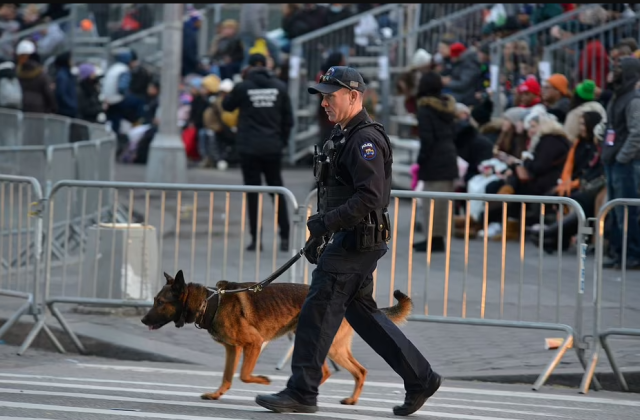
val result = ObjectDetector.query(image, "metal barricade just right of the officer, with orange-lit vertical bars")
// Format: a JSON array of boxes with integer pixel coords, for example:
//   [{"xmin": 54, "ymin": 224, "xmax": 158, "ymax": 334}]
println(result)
[{"xmin": 277, "ymin": 190, "xmax": 590, "ymax": 390}]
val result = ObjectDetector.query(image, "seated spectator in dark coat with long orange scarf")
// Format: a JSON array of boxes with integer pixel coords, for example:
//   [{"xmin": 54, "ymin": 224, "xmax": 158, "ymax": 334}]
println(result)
[{"xmin": 531, "ymin": 111, "xmax": 606, "ymax": 252}]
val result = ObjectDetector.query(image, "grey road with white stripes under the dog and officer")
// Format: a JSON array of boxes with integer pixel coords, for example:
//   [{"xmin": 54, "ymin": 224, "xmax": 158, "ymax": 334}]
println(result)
[{"xmin": 0, "ymin": 346, "xmax": 640, "ymax": 420}]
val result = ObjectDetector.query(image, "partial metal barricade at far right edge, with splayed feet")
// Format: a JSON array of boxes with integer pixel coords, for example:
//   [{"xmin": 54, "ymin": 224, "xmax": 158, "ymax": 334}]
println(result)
[{"xmin": 580, "ymin": 198, "xmax": 640, "ymax": 394}]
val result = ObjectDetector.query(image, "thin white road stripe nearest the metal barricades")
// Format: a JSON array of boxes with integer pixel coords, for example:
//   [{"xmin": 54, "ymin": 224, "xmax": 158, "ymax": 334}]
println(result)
[{"xmin": 37, "ymin": 363, "xmax": 640, "ymax": 407}]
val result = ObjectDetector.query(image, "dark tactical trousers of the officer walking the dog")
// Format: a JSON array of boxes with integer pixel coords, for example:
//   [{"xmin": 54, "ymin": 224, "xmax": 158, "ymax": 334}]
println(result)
[{"xmin": 286, "ymin": 232, "xmax": 431, "ymax": 405}]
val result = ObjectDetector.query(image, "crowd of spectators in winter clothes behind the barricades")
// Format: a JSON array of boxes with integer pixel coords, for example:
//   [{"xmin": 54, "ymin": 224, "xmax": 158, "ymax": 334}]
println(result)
[{"xmin": 0, "ymin": 3, "xmax": 640, "ymax": 268}]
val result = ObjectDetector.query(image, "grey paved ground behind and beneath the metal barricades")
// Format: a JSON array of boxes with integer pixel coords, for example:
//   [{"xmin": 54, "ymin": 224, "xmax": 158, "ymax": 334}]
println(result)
[{"xmin": 0, "ymin": 165, "xmax": 640, "ymax": 394}]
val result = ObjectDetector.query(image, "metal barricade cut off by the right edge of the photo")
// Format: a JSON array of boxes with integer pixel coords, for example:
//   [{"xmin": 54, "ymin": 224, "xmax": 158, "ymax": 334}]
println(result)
[{"xmin": 580, "ymin": 198, "xmax": 640, "ymax": 394}]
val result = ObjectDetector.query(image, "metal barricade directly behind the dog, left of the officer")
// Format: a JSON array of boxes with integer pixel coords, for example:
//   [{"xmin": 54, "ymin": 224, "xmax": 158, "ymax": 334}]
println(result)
[{"xmin": 44, "ymin": 181, "xmax": 300, "ymax": 352}]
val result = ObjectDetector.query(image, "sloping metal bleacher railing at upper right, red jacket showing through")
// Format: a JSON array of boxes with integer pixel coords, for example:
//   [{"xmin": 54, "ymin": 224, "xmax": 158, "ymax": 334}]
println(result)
[{"xmin": 540, "ymin": 16, "xmax": 640, "ymax": 88}]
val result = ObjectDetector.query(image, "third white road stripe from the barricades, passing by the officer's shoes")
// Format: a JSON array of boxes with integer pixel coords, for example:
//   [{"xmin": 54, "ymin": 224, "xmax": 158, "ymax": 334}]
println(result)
[{"xmin": 0, "ymin": 384, "xmax": 563, "ymax": 418}]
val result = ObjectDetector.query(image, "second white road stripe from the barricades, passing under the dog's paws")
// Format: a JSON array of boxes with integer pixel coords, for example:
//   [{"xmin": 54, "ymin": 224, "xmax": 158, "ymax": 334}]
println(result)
[{"xmin": 0, "ymin": 373, "xmax": 601, "ymax": 411}]
